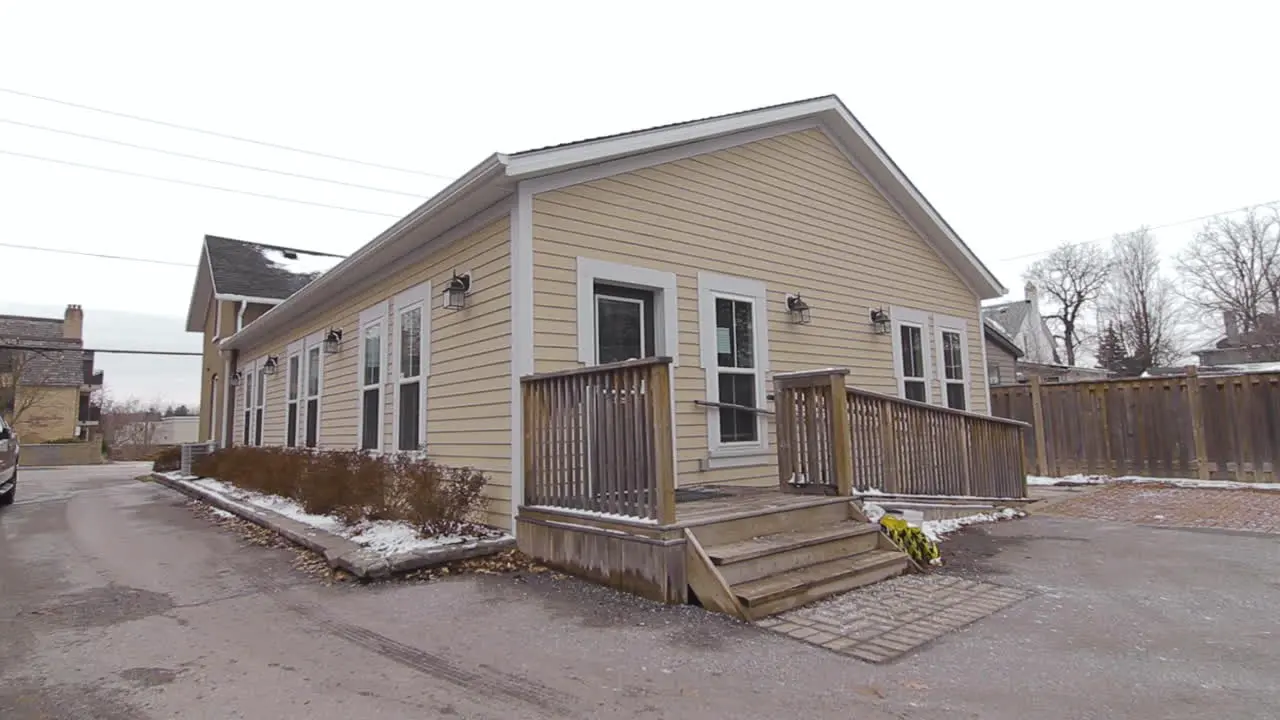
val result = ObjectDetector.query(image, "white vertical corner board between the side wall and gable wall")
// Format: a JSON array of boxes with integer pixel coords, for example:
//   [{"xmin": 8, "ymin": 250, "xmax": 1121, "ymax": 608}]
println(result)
[{"xmin": 511, "ymin": 193, "xmax": 534, "ymax": 525}]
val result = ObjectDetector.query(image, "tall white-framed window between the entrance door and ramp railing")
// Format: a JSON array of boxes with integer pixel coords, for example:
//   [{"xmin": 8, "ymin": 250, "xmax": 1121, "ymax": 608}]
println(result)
[{"xmin": 698, "ymin": 273, "xmax": 768, "ymax": 457}]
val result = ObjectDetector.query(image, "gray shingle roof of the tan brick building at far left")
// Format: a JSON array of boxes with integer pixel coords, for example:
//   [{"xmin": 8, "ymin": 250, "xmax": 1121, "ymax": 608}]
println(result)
[{"xmin": 0, "ymin": 315, "xmax": 84, "ymax": 387}]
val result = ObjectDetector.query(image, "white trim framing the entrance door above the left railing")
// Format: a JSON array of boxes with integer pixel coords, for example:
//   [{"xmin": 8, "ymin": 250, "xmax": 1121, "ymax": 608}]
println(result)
[{"xmin": 577, "ymin": 256, "xmax": 680, "ymax": 366}]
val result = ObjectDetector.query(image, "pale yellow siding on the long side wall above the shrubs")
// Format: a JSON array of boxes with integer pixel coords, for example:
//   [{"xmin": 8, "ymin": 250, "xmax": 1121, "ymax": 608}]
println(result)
[{"xmin": 236, "ymin": 218, "xmax": 511, "ymax": 528}]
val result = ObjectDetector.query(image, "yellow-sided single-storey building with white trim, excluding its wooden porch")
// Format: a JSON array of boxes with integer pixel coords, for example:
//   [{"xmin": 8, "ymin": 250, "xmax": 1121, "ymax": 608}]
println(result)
[{"xmin": 188, "ymin": 96, "xmax": 1005, "ymax": 528}]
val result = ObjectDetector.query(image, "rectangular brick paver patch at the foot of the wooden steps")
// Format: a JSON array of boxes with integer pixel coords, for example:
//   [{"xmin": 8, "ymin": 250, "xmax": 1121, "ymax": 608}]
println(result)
[{"xmin": 758, "ymin": 574, "xmax": 1028, "ymax": 662}]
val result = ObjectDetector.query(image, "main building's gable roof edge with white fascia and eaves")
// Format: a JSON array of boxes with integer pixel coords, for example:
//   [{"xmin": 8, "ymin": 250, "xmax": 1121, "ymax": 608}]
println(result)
[{"xmin": 227, "ymin": 95, "xmax": 1006, "ymax": 347}]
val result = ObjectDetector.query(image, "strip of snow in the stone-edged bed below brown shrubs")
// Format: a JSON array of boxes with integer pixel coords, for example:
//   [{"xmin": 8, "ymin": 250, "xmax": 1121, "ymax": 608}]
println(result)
[{"xmin": 185, "ymin": 474, "xmax": 504, "ymax": 555}]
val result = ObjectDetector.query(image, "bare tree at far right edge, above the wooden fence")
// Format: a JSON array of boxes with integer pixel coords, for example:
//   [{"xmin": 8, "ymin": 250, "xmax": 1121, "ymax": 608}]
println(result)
[{"xmin": 1178, "ymin": 210, "xmax": 1280, "ymax": 332}]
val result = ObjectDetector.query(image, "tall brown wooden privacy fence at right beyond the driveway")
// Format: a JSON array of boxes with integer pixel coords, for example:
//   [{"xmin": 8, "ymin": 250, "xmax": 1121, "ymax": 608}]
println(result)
[{"xmin": 991, "ymin": 368, "xmax": 1280, "ymax": 482}]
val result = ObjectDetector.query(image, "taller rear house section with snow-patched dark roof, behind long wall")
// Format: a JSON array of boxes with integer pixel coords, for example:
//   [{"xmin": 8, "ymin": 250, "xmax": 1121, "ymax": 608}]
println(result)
[{"xmin": 187, "ymin": 234, "xmax": 342, "ymax": 445}]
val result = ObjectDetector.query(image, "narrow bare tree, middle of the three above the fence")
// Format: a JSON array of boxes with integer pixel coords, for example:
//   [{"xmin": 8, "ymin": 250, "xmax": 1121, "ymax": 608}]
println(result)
[{"xmin": 1102, "ymin": 228, "xmax": 1180, "ymax": 369}]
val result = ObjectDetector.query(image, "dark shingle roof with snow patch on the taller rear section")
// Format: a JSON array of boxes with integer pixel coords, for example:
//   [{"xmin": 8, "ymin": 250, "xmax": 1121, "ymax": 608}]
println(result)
[{"xmin": 205, "ymin": 234, "xmax": 342, "ymax": 300}]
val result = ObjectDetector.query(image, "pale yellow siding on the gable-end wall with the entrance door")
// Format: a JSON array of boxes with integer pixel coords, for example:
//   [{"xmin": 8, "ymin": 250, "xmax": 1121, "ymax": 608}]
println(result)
[{"xmin": 534, "ymin": 131, "xmax": 987, "ymax": 484}]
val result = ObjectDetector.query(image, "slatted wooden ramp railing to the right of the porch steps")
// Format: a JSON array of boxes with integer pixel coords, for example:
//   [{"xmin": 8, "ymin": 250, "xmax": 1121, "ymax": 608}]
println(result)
[{"xmin": 773, "ymin": 370, "xmax": 1027, "ymax": 497}]
